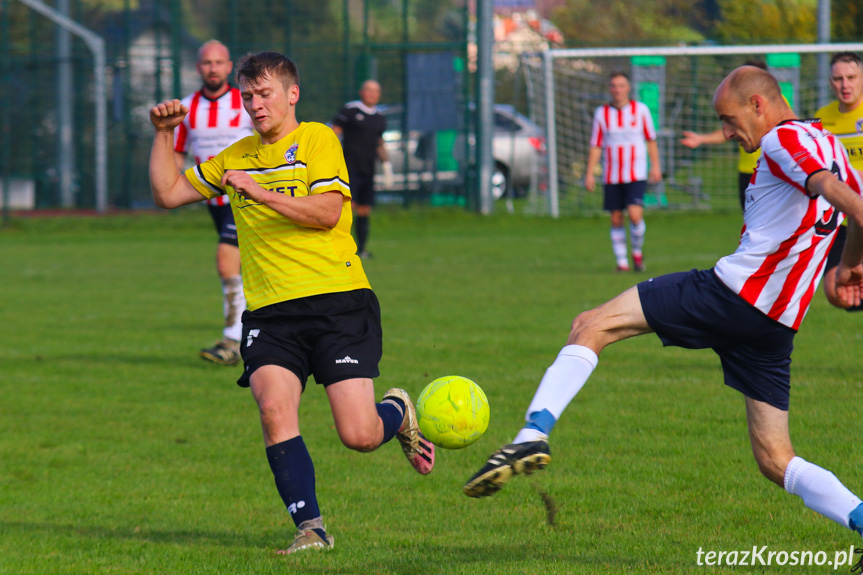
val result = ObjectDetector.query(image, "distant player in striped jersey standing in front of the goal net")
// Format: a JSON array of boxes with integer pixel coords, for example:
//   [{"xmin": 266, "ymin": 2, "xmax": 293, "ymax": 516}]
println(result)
[{"xmin": 584, "ymin": 72, "xmax": 662, "ymax": 272}]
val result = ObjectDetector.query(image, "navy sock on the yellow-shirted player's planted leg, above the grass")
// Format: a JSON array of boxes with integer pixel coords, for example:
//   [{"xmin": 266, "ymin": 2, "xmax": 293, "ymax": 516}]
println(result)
[{"xmin": 267, "ymin": 436, "xmax": 325, "ymax": 537}]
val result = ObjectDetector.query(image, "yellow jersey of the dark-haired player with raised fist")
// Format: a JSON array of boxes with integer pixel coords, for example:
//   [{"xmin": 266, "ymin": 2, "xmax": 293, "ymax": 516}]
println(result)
[{"xmin": 186, "ymin": 122, "xmax": 370, "ymax": 311}]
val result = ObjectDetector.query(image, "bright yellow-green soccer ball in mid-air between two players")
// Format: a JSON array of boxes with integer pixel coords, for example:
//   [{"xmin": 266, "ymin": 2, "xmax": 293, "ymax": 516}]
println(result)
[{"xmin": 417, "ymin": 375, "xmax": 490, "ymax": 449}]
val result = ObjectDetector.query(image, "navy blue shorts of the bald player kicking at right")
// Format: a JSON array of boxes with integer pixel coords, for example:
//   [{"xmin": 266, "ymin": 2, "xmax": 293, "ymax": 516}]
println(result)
[{"xmin": 638, "ymin": 270, "xmax": 796, "ymax": 411}]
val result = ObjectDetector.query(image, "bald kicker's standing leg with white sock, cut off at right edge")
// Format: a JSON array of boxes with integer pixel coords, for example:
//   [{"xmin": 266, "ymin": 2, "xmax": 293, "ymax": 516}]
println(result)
[{"xmin": 746, "ymin": 397, "xmax": 863, "ymax": 533}]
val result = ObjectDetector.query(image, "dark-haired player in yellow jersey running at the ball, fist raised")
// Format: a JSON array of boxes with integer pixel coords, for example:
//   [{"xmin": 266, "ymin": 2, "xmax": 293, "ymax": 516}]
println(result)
[{"xmin": 150, "ymin": 52, "xmax": 434, "ymax": 553}]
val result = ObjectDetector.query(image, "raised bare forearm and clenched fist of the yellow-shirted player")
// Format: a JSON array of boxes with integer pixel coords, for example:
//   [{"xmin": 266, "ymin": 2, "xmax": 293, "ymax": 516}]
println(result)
[{"xmin": 150, "ymin": 100, "xmax": 204, "ymax": 208}]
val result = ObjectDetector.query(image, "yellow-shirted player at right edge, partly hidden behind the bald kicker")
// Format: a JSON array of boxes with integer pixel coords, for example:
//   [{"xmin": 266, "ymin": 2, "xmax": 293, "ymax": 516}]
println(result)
[{"xmin": 815, "ymin": 52, "xmax": 863, "ymax": 311}]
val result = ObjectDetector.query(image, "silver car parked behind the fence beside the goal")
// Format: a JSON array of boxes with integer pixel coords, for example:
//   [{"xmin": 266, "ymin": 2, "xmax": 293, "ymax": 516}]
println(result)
[{"xmin": 375, "ymin": 104, "xmax": 546, "ymax": 199}]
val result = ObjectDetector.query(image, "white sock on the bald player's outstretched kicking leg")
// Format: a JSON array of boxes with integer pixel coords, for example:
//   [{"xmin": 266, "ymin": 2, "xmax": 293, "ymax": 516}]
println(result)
[{"xmin": 513, "ymin": 345, "xmax": 599, "ymax": 443}]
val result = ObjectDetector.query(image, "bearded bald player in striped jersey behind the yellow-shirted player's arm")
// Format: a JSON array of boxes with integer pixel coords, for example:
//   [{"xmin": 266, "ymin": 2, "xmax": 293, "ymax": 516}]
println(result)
[{"xmin": 174, "ymin": 40, "xmax": 254, "ymax": 365}]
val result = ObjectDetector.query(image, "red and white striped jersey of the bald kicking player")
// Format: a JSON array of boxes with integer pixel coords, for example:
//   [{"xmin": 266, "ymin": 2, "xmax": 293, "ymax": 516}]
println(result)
[{"xmin": 715, "ymin": 120, "xmax": 863, "ymax": 330}]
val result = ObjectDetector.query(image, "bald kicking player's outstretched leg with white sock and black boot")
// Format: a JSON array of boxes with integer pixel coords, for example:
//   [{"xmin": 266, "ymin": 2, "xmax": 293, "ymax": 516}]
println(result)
[{"xmin": 464, "ymin": 287, "xmax": 652, "ymax": 497}]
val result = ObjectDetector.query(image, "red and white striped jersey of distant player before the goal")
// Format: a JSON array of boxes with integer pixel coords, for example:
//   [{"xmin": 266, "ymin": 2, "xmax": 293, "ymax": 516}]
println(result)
[{"xmin": 590, "ymin": 100, "xmax": 656, "ymax": 184}]
